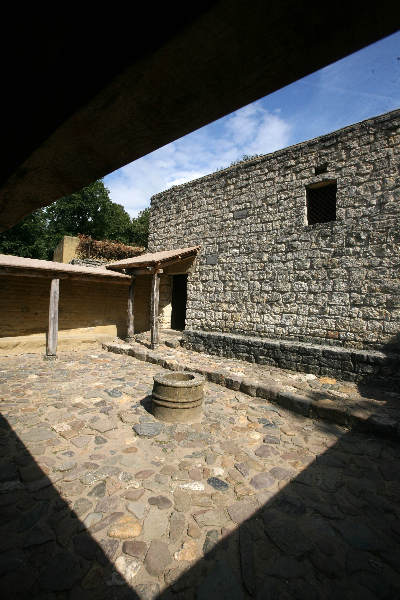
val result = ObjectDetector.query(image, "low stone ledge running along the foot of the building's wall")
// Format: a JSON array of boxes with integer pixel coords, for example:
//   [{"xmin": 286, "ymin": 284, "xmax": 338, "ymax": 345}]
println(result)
[{"xmin": 183, "ymin": 330, "xmax": 400, "ymax": 389}]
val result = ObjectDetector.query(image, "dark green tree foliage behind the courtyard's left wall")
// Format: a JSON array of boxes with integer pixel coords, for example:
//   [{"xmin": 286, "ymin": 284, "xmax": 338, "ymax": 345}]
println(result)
[{"xmin": 0, "ymin": 180, "xmax": 149, "ymax": 260}]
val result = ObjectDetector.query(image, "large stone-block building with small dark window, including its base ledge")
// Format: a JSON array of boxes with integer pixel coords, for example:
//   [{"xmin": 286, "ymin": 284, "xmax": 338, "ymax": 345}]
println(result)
[{"xmin": 149, "ymin": 110, "xmax": 400, "ymax": 379}]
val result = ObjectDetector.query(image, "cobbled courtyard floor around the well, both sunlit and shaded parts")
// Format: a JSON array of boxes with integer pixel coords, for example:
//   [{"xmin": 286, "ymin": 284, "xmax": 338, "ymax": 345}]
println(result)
[{"xmin": 0, "ymin": 350, "xmax": 400, "ymax": 600}]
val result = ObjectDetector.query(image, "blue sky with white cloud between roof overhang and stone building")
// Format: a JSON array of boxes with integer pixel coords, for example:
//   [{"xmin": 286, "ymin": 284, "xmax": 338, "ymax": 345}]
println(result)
[{"xmin": 104, "ymin": 32, "xmax": 400, "ymax": 216}]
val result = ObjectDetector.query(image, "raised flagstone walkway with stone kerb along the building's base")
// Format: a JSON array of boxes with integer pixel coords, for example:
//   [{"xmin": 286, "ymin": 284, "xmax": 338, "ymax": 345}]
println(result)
[{"xmin": 107, "ymin": 330, "xmax": 400, "ymax": 438}]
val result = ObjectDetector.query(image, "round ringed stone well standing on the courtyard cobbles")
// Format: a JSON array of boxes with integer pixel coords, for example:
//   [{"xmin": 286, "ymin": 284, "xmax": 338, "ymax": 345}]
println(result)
[{"xmin": 152, "ymin": 371, "xmax": 205, "ymax": 423}]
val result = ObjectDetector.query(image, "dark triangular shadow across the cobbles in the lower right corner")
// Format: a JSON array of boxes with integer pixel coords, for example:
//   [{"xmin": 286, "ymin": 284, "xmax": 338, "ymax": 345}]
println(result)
[{"xmin": 160, "ymin": 410, "xmax": 400, "ymax": 600}]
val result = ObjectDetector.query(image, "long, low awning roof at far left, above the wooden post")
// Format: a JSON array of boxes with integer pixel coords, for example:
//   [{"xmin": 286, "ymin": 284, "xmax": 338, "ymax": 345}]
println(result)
[{"xmin": 0, "ymin": 254, "xmax": 131, "ymax": 284}]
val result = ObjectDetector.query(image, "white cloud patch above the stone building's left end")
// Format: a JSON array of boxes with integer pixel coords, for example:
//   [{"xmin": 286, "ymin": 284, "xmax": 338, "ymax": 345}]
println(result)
[{"xmin": 105, "ymin": 101, "xmax": 290, "ymax": 216}]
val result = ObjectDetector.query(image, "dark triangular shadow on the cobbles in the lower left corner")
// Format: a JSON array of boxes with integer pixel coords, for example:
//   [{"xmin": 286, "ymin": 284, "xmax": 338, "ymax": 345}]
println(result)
[{"xmin": 0, "ymin": 417, "xmax": 139, "ymax": 600}]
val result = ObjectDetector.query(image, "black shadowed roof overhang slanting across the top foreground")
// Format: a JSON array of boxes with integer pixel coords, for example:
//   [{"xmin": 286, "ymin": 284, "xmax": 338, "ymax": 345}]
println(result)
[{"xmin": 0, "ymin": 0, "xmax": 400, "ymax": 231}]
